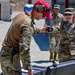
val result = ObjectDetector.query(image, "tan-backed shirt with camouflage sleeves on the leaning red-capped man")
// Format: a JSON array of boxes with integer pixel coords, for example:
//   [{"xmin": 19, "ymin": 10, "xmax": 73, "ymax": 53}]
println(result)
[{"xmin": 2, "ymin": 13, "xmax": 40, "ymax": 69}]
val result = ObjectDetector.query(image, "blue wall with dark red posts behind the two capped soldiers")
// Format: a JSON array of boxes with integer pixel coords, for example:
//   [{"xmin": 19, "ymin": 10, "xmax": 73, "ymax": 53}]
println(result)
[{"xmin": 52, "ymin": 0, "xmax": 75, "ymax": 14}]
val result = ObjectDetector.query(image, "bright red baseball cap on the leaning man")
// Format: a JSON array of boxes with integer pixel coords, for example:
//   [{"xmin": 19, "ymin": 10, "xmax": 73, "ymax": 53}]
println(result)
[{"xmin": 34, "ymin": 0, "xmax": 53, "ymax": 19}]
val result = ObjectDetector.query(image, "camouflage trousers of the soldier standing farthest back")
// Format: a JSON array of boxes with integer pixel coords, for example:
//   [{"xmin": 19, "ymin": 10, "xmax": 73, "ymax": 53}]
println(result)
[{"xmin": 50, "ymin": 37, "xmax": 59, "ymax": 61}]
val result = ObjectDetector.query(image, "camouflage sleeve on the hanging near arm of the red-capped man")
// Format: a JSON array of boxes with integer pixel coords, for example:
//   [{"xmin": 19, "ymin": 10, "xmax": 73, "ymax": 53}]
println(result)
[{"xmin": 19, "ymin": 25, "xmax": 32, "ymax": 70}]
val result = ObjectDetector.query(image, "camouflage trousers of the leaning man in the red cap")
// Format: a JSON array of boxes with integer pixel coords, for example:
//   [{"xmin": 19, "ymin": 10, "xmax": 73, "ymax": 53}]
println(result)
[{"xmin": 0, "ymin": 48, "xmax": 22, "ymax": 75}]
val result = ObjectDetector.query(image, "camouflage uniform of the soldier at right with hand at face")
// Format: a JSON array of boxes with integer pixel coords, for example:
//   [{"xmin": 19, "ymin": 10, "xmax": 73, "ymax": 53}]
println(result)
[{"xmin": 59, "ymin": 21, "xmax": 75, "ymax": 62}]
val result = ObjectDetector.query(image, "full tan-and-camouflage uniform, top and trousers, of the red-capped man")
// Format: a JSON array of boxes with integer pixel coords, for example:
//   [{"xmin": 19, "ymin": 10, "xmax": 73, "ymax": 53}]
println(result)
[{"xmin": 0, "ymin": 13, "xmax": 40, "ymax": 75}]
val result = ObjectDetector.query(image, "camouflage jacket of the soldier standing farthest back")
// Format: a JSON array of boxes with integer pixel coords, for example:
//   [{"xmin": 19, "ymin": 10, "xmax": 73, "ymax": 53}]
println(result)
[{"xmin": 50, "ymin": 13, "xmax": 65, "ymax": 45}]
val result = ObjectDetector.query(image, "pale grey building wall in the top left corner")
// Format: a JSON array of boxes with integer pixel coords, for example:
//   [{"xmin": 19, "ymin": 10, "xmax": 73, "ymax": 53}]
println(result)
[{"xmin": 0, "ymin": 0, "xmax": 10, "ymax": 20}]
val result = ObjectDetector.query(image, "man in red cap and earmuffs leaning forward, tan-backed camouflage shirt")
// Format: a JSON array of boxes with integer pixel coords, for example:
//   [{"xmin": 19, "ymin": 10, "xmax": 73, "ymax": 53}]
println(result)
[{"xmin": 0, "ymin": 0, "xmax": 52, "ymax": 75}]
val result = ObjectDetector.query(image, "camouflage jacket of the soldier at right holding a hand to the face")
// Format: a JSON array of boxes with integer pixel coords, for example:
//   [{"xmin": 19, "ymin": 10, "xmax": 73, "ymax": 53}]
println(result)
[{"xmin": 52, "ymin": 21, "xmax": 75, "ymax": 54}]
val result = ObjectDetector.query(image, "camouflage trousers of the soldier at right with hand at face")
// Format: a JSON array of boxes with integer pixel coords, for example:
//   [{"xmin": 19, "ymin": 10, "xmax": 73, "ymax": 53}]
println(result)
[{"xmin": 59, "ymin": 45, "xmax": 71, "ymax": 63}]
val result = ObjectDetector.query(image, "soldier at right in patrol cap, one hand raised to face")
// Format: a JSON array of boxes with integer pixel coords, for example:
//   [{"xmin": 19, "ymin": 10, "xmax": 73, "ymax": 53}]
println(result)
[{"xmin": 51, "ymin": 9, "xmax": 75, "ymax": 62}]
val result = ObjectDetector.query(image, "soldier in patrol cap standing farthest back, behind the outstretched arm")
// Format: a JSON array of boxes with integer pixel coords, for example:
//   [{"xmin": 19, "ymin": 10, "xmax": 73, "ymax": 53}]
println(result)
[{"xmin": 50, "ymin": 4, "xmax": 65, "ymax": 61}]
